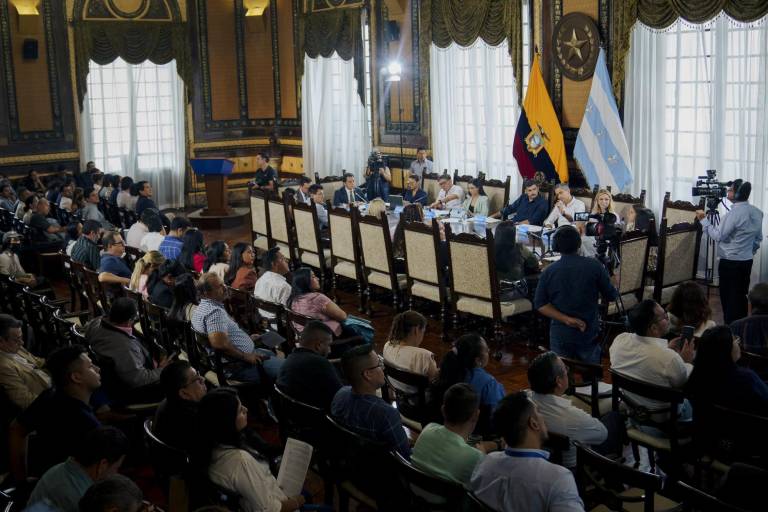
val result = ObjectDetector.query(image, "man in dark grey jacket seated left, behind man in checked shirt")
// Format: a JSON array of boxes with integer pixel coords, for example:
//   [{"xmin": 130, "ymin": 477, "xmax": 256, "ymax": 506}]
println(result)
[{"xmin": 85, "ymin": 297, "xmax": 170, "ymax": 403}]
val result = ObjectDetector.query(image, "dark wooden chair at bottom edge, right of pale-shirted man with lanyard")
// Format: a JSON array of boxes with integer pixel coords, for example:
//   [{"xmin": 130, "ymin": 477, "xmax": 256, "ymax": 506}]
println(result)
[{"xmin": 576, "ymin": 442, "xmax": 677, "ymax": 512}]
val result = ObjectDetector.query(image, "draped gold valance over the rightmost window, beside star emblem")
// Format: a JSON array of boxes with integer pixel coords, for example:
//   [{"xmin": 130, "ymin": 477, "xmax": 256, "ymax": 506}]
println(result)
[{"xmin": 611, "ymin": 0, "xmax": 768, "ymax": 106}]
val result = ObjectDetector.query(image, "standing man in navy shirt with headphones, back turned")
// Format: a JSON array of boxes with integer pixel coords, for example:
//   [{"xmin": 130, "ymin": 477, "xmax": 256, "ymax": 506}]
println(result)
[{"xmin": 533, "ymin": 226, "xmax": 618, "ymax": 364}]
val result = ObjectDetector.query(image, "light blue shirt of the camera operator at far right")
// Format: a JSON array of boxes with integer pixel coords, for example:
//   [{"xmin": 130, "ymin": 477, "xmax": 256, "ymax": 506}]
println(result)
[{"xmin": 701, "ymin": 202, "xmax": 763, "ymax": 261}]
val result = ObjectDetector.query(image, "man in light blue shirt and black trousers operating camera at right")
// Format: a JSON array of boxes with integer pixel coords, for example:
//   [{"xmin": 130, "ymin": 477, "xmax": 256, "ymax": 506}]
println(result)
[{"xmin": 696, "ymin": 180, "xmax": 763, "ymax": 324}]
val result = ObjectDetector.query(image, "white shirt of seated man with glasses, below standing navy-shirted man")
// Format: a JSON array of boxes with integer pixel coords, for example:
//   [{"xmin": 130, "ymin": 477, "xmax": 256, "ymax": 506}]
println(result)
[{"xmin": 530, "ymin": 391, "xmax": 608, "ymax": 468}]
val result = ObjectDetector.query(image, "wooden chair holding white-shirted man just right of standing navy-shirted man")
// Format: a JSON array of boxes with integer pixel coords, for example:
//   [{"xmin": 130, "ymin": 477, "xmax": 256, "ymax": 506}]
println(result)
[{"xmin": 610, "ymin": 369, "xmax": 691, "ymax": 470}]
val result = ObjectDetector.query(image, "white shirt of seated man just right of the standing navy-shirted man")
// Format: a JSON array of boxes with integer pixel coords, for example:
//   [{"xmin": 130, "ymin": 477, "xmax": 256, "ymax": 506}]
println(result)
[{"xmin": 610, "ymin": 332, "xmax": 693, "ymax": 409}]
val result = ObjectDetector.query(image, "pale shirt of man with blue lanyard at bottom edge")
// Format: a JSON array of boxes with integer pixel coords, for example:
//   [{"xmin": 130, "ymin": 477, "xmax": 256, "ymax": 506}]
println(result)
[{"xmin": 470, "ymin": 448, "xmax": 584, "ymax": 512}]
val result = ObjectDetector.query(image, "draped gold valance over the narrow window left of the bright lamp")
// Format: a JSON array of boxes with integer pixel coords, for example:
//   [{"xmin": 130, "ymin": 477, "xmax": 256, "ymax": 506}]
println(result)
[{"xmin": 299, "ymin": 8, "xmax": 365, "ymax": 105}]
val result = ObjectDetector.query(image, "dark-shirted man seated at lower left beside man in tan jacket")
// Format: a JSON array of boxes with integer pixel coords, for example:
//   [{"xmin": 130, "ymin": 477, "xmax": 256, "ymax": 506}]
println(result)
[{"xmin": 10, "ymin": 345, "xmax": 101, "ymax": 482}]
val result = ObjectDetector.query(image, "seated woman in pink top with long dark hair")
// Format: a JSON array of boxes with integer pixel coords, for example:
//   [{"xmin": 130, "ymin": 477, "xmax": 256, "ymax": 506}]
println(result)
[{"xmin": 288, "ymin": 267, "xmax": 356, "ymax": 337}]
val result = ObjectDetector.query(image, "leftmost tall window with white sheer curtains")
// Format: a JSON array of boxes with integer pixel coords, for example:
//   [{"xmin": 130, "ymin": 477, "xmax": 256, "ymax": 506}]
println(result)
[{"xmin": 81, "ymin": 59, "xmax": 186, "ymax": 207}]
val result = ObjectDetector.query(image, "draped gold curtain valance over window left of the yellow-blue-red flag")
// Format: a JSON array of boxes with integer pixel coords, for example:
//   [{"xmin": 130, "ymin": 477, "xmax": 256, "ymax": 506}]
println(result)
[{"xmin": 424, "ymin": 0, "xmax": 523, "ymax": 103}]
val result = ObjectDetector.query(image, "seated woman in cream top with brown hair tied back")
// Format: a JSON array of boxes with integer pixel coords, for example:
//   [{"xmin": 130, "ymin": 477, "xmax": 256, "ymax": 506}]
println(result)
[{"xmin": 382, "ymin": 311, "xmax": 438, "ymax": 393}]
